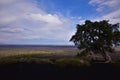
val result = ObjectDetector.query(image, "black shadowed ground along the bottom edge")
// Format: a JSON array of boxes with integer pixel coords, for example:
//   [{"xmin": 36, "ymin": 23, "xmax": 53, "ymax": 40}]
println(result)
[{"xmin": 0, "ymin": 63, "xmax": 120, "ymax": 80}]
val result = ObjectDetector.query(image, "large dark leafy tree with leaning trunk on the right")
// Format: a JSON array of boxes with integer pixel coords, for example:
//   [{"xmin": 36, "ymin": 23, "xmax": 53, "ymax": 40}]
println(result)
[{"xmin": 70, "ymin": 20, "xmax": 120, "ymax": 63}]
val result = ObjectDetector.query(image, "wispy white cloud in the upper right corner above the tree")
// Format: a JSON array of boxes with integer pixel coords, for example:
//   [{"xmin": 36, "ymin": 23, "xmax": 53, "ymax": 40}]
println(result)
[{"xmin": 83, "ymin": 0, "xmax": 120, "ymax": 23}]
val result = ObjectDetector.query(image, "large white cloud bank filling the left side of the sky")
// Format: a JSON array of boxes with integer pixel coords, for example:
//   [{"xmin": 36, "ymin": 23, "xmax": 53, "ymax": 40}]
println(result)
[{"xmin": 0, "ymin": 0, "xmax": 73, "ymax": 43}]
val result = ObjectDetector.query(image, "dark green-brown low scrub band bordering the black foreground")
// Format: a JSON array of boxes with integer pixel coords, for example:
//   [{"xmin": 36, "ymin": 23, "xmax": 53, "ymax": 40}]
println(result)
[{"xmin": 0, "ymin": 54, "xmax": 90, "ymax": 67}]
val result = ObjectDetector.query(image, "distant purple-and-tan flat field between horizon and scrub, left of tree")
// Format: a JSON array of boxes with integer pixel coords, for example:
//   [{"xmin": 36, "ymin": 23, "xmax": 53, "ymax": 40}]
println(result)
[{"xmin": 0, "ymin": 46, "xmax": 78, "ymax": 58}]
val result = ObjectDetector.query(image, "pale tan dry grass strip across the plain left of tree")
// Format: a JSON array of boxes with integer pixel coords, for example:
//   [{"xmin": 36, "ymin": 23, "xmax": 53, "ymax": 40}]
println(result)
[{"xmin": 0, "ymin": 48, "xmax": 75, "ymax": 58}]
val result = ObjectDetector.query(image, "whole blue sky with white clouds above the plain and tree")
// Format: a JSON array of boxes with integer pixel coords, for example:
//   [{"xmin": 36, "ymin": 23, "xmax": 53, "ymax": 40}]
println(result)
[{"xmin": 0, "ymin": 0, "xmax": 120, "ymax": 45}]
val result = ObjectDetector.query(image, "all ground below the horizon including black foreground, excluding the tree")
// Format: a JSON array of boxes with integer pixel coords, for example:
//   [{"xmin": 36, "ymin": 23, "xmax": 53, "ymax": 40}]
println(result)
[{"xmin": 0, "ymin": 46, "xmax": 120, "ymax": 80}]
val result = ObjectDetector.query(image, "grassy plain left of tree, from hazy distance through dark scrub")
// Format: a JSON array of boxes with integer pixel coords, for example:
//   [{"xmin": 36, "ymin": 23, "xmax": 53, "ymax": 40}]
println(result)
[{"xmin": 0, "ymin": 47, "xmax": 89, "ymax": 67}]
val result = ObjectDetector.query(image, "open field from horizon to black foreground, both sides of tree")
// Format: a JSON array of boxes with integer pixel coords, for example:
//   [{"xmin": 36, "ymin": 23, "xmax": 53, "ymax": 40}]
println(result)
[{"xmin": 0, "ymin": 45, "xmax": 120, "ymax": 64}]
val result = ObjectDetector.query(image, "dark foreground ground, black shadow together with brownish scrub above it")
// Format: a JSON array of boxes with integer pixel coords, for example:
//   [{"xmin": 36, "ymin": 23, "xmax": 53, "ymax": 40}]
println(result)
[{"xmin": 0, "ymin": 55, "xmax": 120, "ymax": 80}]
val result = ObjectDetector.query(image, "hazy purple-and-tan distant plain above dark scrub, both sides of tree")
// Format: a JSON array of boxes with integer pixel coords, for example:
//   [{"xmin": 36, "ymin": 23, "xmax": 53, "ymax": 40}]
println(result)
[{"xmin": 0, "ymin": 45, "xmax": 120, "ymax": 59}]
